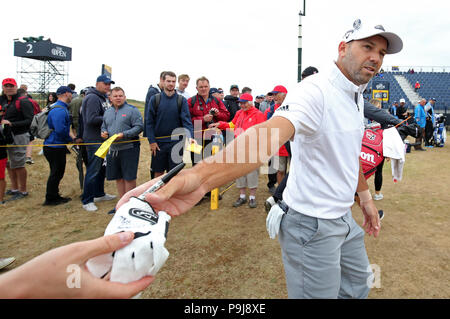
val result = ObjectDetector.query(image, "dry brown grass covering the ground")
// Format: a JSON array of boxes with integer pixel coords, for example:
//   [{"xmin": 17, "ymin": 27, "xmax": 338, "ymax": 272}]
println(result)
[{"xmin": 0, "ymin": 136, "xmax": 450, "ymax": 298}]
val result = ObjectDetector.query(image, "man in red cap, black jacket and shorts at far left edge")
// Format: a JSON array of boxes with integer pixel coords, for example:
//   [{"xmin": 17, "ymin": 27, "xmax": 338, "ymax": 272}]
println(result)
[{"xmin": 0, "ymin": 78, "xmax": 34, "ymax": 200}]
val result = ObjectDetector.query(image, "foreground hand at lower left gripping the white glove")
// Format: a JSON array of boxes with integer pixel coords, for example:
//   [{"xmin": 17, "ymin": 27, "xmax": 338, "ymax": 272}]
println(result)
[{"xmin": 0, "ymin": 232, "xmax": 154, "ymax": 299}]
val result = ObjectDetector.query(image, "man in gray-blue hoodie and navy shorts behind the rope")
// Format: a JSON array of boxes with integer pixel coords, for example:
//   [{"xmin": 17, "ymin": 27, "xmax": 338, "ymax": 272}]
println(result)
[{"xmin": 101, "ymin": 87, "xmax": 144, "ymax": 197}]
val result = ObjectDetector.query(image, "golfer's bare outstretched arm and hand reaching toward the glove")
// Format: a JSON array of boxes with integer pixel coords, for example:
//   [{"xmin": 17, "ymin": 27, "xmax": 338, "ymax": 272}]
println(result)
[{"xmin": 116, "ymin": 117, "xmax": 294, "ymax": 216}]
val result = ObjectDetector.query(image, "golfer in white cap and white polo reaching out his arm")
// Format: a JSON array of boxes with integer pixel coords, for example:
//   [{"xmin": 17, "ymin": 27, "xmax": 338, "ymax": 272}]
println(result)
[{"xmin": 118, "ymin": 20, "xmax": 403, "ymax": 299}]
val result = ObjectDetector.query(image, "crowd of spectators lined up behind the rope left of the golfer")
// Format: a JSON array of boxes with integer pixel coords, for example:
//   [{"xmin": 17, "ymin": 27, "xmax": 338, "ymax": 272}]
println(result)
[{"xmin": 0, "ymin": 71, "xmax": 298, "ymax": 212}]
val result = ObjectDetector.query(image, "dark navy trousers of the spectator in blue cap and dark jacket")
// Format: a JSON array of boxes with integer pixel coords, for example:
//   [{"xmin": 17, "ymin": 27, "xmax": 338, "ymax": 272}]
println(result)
[{"xmin": 81, "ymin": 144, "xmax": 106, "ymax": 205}]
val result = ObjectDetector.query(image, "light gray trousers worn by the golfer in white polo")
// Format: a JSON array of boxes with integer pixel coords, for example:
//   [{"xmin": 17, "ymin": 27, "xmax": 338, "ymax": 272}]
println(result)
[{"xmin": 279, "ymin": 208, "xmax": 373, "ymax": 299}]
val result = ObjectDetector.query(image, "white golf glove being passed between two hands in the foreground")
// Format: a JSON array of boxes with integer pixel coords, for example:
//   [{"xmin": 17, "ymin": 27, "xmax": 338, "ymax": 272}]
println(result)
[{"xmin": 86, "ymin": 197, "xmax": 171, "ymax": 283}]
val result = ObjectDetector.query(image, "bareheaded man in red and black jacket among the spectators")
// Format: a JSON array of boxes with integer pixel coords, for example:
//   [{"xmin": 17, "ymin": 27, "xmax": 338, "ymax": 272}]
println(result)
[{"xmin": 188, "ymin": 76, "xmax": 230, "ymax": 165}]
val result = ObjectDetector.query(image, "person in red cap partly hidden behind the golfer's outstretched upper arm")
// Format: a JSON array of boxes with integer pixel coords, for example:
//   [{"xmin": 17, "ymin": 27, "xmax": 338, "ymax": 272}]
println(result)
[{"xmin": 264, "ymin": 85, "xmax": 289, "ymax": 185}]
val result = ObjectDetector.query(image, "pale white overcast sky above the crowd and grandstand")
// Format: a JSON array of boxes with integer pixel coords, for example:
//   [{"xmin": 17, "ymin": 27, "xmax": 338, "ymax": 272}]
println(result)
[{"xmin": 0, "ymin": 0, "xmax": 450, "ymax": 100}]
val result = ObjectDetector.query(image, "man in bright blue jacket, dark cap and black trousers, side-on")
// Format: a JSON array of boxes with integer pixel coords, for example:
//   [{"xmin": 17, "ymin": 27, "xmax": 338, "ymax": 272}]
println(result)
[{"xmin": 43, "ymin": 86, "xmax": 75, "ymax": 206}]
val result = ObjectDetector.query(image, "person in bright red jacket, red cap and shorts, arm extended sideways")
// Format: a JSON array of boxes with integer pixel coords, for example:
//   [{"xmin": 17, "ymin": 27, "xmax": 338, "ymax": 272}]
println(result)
[{"xmin": 209, "ymin": 93, "xmax": 266, "ymax": 208}]
